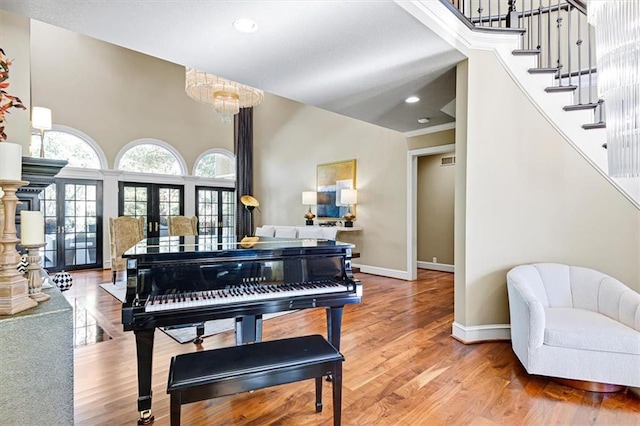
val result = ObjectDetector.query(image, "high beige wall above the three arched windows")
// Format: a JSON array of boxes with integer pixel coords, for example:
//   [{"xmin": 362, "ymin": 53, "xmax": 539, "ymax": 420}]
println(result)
[{"xmin": 31, "ymin": 21, "xmax": 233, "ymax": 172}]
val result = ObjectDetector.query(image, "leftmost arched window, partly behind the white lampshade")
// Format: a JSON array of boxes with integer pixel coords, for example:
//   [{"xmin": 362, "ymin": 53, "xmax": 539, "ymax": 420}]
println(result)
[{"xmin": 40, "ymin": 126, "xmax": 106, "ymax": 169}]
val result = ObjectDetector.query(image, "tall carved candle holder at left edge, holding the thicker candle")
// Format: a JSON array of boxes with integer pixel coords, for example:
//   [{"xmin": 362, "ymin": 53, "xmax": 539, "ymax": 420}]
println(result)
[{"xmin": 0, "ymin": 180, "xmax": 38, "ymax": 315}]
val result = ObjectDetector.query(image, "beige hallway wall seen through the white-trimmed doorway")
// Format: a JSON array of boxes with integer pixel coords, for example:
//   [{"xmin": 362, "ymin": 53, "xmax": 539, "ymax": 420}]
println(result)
[{"xmin": 417, "ymin": 153, "xmax": 456, "ymax": 265}]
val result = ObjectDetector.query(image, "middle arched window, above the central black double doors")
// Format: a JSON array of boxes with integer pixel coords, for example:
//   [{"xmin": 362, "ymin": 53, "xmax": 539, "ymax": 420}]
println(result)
[{"xmin": 116, "ymin": 140, "xmax": 185, "ymax": 175}]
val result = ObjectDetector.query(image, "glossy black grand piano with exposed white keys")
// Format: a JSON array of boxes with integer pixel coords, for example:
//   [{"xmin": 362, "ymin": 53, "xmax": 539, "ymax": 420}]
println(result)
[{"xmin": 122, "ymin": 236, "xmax": 362, "ymax": 424}]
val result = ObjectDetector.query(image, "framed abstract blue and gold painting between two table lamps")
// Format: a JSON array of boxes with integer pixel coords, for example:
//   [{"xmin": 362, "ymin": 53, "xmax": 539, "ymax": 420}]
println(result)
[{"xmin": 316, "ymin": 160, "xmax": 356, "ymax": 220}]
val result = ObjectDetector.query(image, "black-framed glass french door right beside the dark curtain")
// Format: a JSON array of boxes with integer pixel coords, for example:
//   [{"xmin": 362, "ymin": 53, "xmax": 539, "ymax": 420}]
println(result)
[{"xmin": 196, "ymin": 186, "xmax": 236, "ymax": 243}]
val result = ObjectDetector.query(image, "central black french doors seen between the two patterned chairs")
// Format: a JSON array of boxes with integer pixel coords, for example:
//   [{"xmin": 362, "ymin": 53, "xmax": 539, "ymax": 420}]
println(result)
[{"xmin": 118, "ymin": 182, "xmax": 184, "ymax": 238}]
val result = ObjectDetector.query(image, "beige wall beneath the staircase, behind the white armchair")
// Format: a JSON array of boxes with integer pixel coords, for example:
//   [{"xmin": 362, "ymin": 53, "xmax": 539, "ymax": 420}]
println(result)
[{"xmin": 456, "ymin": 51, "xmax": 640, "ymax": 326}]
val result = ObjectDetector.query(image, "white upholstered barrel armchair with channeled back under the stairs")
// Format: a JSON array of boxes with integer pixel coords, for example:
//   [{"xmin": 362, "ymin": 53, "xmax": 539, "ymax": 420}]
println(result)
[{"xmin": 507, "ymin": 263, "xmax": 640, "ymax": 387}]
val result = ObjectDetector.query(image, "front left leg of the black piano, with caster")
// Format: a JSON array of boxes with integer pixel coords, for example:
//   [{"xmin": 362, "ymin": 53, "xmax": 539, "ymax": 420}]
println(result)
[{"xmin": 134, "ymin": 328, "xmax": 155, "ymax": 425}]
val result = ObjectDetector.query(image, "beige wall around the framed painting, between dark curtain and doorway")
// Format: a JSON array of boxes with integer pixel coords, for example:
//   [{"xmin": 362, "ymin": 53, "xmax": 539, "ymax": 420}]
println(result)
[{"xmin": 254, "ymin": 95, "xmax": 407, "ymax": 270}]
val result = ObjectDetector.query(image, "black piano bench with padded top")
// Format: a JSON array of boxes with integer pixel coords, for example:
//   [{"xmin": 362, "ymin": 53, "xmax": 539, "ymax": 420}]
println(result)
[{"xmin": 167, "ymin": 334, "xmax": 344, "ymax": 426}]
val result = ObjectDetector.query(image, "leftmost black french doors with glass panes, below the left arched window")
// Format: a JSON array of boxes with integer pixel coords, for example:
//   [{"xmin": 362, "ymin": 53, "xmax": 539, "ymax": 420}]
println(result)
[{"xmin": 40, "ymin": 179, "xmax": 102, "ymax": 272}]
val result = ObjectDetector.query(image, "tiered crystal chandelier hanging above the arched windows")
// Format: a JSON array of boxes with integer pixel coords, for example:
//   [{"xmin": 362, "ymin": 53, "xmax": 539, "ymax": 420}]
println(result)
[{"xmin": 184, "ymin": 67, "xmax": 264, "ymax": 123}]
